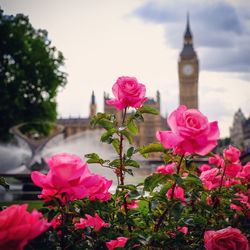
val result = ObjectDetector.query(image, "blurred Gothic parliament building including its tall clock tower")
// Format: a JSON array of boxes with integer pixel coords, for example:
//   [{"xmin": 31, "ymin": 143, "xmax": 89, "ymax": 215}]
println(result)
[{"xmin": 58, "ymin": 17, "xmax": 199, "ymax": 146}]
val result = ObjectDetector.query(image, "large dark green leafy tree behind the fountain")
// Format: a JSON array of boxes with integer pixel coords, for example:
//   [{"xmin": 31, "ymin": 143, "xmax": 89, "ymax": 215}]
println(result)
[{"xmin": 0, "ymin": 9, "xmax": 66, "ymax": 141}]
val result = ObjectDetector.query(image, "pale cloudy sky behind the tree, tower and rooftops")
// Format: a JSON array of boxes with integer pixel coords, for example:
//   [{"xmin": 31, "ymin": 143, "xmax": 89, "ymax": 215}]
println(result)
[{"xmin": 0, "ymin": 0, "xmax": 250, "ymax": 137}]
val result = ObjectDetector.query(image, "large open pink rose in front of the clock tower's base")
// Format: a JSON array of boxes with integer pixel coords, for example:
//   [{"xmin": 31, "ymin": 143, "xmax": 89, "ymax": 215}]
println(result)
[{"xmin": 156, "ymin": 105, "xmax": 219, "ymax": 155}]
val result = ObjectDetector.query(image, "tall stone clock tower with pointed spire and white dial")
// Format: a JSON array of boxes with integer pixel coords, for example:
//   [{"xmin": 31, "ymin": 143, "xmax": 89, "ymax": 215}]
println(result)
[{"xmin": 178, "ymin": 16, "xmax": 199, "ymax": 109}]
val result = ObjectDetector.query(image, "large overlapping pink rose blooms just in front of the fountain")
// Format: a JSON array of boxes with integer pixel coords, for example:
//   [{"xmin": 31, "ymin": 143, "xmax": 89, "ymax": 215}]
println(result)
[{"xmin": 31, "ymin": 154, "xmax": 112, "ymax": 202}]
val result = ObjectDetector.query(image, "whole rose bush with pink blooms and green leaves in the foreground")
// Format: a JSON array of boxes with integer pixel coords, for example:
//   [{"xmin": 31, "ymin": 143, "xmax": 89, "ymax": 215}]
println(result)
[{"xmin": 0, "ymin": 77, "xmax": 250, "ymax": 250}]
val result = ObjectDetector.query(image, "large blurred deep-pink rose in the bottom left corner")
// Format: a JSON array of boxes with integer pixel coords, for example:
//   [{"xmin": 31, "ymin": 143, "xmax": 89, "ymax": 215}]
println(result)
[{"xmin": 0, "ymin": 204, "xmax": 51, "ymax": 250}]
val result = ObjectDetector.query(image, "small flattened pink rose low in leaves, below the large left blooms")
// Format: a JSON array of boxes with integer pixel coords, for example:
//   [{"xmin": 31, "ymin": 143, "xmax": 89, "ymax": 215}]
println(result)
[{"xmin": 75, "ymin": 214, "xmax": 109, "ymax": 232}]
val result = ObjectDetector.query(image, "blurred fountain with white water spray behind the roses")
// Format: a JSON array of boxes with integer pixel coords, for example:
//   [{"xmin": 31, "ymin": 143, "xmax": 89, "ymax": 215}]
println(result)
[{"xmin": 0, "ymin": 124, "xmax": 159, "ymax": 200}]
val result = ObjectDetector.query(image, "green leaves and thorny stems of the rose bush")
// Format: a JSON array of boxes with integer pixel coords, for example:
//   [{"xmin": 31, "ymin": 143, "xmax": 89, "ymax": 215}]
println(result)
[{"xmin": 4, "ymin": 106, "xmax": 250, "ymax": 250}]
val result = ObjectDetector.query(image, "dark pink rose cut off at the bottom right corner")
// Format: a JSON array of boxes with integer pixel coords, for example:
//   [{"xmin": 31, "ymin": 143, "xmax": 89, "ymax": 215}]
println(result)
[{"xmin": 204, "ymin": 227, "xmax": 249, "ymax": 250}]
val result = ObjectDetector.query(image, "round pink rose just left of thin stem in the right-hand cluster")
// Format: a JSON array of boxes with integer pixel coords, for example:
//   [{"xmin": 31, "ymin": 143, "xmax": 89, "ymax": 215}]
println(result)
[{"xmin": 200, "ymin": 168, "xmax": 221, "ymax": 190}]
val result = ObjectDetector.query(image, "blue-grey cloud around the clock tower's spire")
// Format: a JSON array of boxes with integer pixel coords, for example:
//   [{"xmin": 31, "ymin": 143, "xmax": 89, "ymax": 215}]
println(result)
[{"xmin": 133, "ymin": 0, "xmax": 250, "ymax": 79}]
